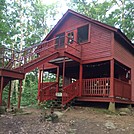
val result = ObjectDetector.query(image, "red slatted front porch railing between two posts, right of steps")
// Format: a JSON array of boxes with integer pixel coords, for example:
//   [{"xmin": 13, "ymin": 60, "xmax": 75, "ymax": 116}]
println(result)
[{"xmin": 82, "ymin": 78, "xmax": 110, "ymax": 97}]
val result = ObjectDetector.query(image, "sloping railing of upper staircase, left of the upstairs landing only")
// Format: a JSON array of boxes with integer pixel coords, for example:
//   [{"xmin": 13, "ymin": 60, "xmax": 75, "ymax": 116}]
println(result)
[{"xmin": 0, "ymin": 38, "xmax": 57, "ymax": 69}]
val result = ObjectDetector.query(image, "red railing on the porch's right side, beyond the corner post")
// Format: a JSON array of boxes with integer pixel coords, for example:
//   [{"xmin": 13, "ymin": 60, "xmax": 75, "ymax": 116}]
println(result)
[{"xmin": 114, "ymin": 79, "xmax": 131, "ymax": 100}]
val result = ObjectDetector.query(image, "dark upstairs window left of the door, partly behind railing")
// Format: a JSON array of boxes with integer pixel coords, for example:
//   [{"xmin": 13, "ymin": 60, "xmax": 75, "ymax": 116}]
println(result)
[{"xmin": 55, "ymin": 33, "xmax": 65, "ymax": 48}]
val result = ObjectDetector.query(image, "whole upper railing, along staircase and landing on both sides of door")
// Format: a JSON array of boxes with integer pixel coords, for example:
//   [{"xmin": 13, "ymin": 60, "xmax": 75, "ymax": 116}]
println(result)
[{"xmin": 0, "ymin": 37, "xmax": 81, "ymax": 69}]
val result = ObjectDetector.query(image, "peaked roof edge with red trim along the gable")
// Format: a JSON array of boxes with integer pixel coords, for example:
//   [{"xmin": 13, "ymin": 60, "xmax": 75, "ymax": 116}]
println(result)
[{"xmin": 43, "ymin": 9, "xmax": 134, "ymax": 53}]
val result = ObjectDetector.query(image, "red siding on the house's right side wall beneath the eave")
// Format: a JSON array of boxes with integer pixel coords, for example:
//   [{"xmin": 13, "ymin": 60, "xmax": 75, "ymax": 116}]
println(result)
[{"xmin": 114, "ymin": 40, "xmax": 134, "ymax": 101}]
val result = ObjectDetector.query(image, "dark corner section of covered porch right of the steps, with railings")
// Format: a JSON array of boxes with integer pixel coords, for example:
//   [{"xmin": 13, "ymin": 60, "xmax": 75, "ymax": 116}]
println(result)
[{"xmin": 81, "ymin": 60, "xmax": 131, "ymax": 101}]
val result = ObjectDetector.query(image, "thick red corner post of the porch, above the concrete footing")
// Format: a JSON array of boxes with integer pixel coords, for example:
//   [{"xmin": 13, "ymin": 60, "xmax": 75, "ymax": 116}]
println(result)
[{"xmin": 109, "ymin": 59, "xmax": 114, "ymax": 102}]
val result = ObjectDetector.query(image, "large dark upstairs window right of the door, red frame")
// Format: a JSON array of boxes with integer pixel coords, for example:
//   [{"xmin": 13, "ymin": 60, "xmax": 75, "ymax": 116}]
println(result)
[{"xmin": 77, "ymin": 25, "xmax": 89, "ymax": 43}]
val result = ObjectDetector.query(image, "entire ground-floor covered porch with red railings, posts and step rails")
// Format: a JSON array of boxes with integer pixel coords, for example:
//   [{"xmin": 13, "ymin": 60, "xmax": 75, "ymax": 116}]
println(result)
[{"xmin": 38, "ymin": 60, "xmax": 131, "ymax": 104}]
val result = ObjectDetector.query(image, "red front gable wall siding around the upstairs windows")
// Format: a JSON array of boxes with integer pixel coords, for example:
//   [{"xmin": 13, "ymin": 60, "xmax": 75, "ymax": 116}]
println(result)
[{"xmin": 42, "ymin": 15, "xmax": 112, "ymax": 70}]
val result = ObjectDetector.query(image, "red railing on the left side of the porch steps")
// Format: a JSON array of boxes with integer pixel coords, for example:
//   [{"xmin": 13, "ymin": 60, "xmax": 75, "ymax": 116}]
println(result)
[{"xmin": 38, "ymin": 82, "xmax": 58, "ymax": 102}]
